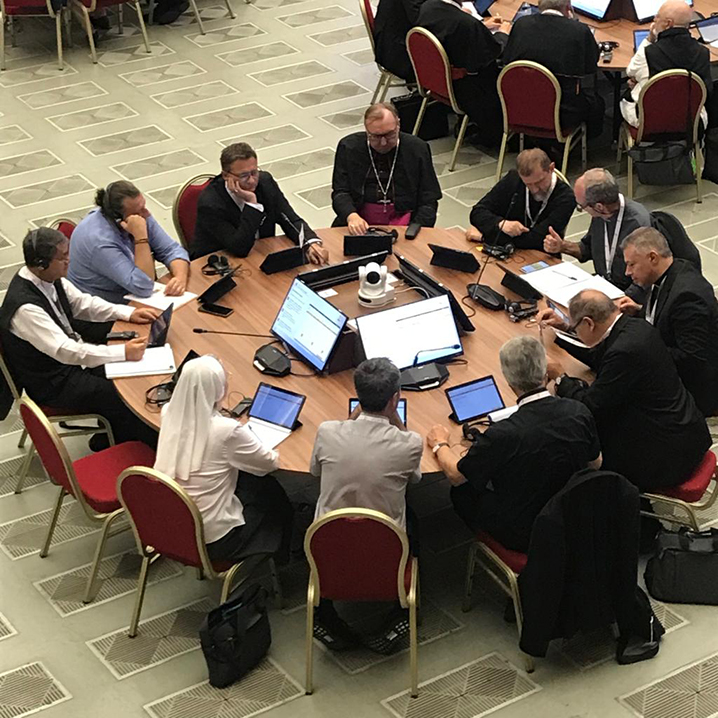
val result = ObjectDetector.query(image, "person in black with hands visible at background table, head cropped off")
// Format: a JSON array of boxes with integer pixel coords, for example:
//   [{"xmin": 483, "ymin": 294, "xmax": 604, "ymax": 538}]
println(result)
[{"xmin": 416, "ymin": 0, "xmax": 511, "ymax": 147}]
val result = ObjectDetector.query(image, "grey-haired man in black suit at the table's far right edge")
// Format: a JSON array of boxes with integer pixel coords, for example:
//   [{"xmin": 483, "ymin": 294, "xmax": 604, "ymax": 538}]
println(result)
[{"xmin": 618, "ymin": 227, "xmax": 718, "ymax": 416}]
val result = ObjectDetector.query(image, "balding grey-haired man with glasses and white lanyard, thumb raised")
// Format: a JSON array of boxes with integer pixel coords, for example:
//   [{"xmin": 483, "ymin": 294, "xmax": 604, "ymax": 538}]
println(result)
[{"xmin": 544, "ymin": 168, "xmax": 651, "ymax": 303}]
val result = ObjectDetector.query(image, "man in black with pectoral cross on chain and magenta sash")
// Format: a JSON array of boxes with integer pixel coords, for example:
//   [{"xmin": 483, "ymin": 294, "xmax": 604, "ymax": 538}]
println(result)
[{"xmin": 332, "ymin": 102, "xmax": 441, "ymax": 234}]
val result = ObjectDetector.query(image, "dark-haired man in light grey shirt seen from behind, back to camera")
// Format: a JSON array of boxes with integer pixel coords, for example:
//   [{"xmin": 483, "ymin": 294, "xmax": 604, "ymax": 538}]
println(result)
[{"xmin": 310, "ymin": 358, "xmax": 423, "ymax": 653}]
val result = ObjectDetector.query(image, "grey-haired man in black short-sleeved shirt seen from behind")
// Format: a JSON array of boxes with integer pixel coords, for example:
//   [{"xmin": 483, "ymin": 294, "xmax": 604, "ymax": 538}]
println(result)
[{"xmin": 426, "ymin": 336, "xmax": 601, "ymax": 553}]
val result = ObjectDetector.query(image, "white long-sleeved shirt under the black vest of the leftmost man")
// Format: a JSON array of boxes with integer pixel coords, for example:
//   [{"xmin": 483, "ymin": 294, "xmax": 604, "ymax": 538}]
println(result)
[{"xmin": 10, "ymin": 267, "xmax": 135, "ymax": 368}]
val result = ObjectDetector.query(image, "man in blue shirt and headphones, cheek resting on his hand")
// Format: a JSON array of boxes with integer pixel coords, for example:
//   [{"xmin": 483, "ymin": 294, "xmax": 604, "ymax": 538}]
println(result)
[{"xmin": 68, "ymin": 180, "xmax": 189, "ymax": 304}]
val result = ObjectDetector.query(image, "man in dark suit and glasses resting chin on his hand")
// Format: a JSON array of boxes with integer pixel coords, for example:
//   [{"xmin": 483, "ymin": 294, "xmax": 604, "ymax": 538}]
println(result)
[{"xmin": 190, "ymin": 142, "xmax": 329, "ymax": 264}]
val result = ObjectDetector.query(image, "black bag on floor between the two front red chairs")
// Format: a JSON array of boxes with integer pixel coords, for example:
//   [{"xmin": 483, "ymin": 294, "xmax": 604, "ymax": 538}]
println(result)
[{"xmin": 199, "ymin": 583, "xmax": 272, "ymax": 688}]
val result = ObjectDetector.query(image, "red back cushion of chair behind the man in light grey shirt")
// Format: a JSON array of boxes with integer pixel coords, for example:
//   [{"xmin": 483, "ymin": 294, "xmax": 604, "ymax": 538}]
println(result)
[{"xmin": 308, "ymin": 517, "xmax": 405, "ymax": 601}]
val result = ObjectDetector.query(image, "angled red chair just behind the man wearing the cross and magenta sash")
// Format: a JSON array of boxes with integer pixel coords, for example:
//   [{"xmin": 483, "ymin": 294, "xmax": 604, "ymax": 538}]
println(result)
[{"xmin": 406, "ymin": 27, "xmax": 469, "ymax": 172}]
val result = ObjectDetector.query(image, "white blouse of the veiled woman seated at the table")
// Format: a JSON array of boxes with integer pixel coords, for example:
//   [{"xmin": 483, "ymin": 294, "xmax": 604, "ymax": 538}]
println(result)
[{"xmin": 177, "ymin": 413, "xmax": 279, "ymax": 543}]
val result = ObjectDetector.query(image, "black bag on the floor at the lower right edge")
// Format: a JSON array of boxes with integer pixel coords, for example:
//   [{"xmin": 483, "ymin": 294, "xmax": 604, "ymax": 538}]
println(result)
[{"xmin": 644, "ymin": 528, "xmax": 718, "ymax": 605}]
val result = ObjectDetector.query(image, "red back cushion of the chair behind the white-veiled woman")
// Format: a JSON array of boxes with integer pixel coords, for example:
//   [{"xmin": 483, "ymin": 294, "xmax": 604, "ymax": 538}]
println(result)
[{"xmin": 117, "ymin": 473, "xmax": 202, "ymax": 567}]
